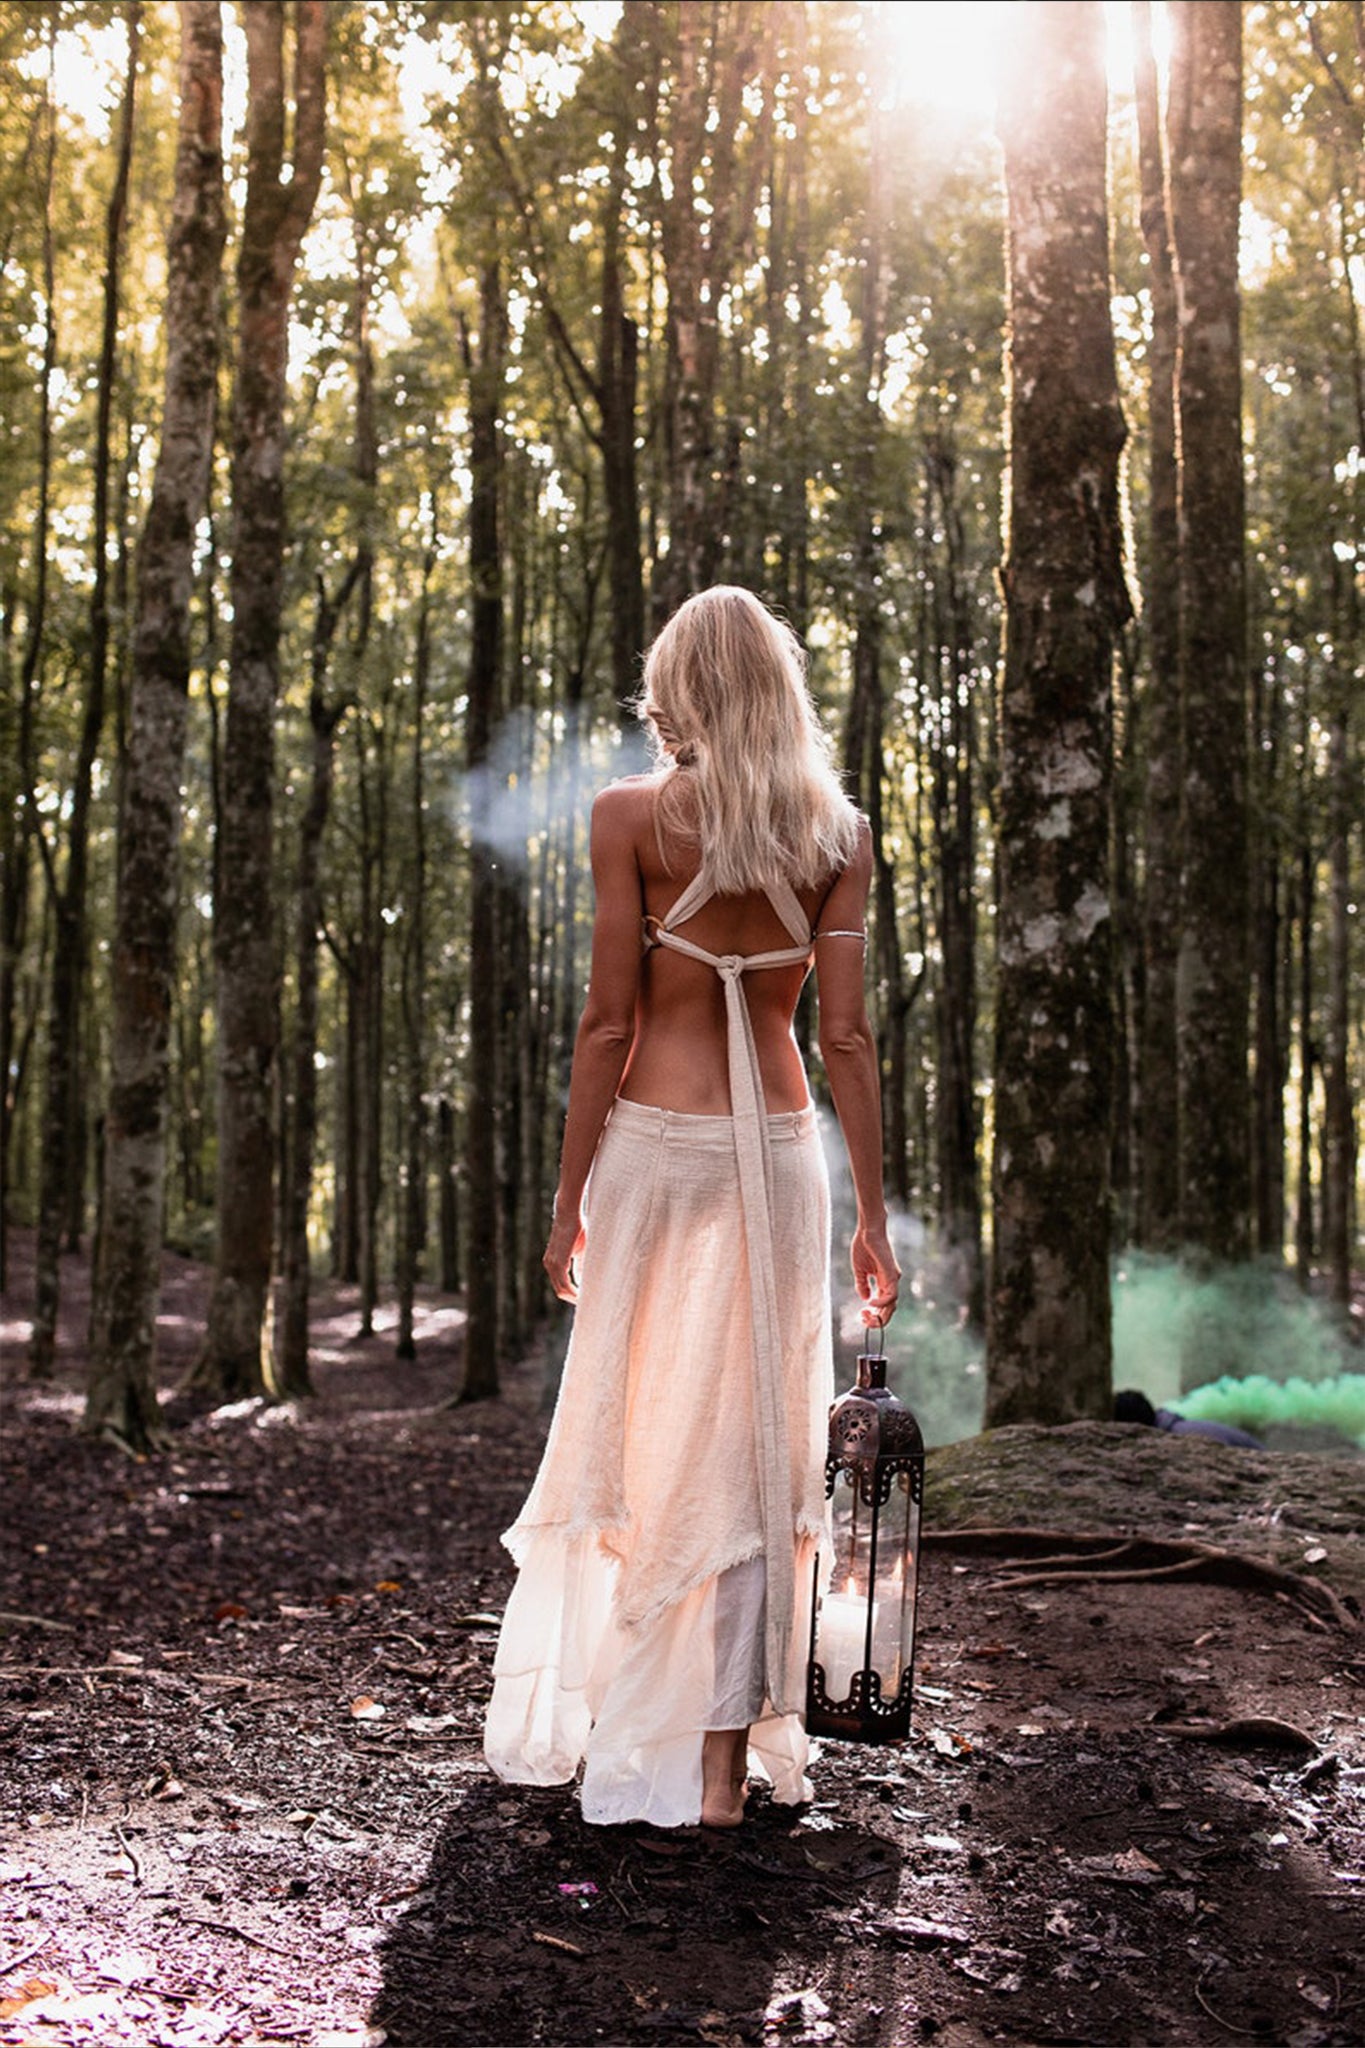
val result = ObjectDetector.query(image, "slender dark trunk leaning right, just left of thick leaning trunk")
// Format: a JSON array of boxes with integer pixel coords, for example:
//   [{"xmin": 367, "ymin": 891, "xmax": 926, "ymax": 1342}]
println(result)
[{"xmin": 29, "ymin": 0, "xmax": 141, "ymax": 1378}]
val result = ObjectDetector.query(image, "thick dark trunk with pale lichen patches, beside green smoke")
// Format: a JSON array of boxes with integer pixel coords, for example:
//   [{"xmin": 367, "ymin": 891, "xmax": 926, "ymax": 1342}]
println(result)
[{"xmin": 986, "ymin": 0, "xmax": 1128, "ymax": 1425}]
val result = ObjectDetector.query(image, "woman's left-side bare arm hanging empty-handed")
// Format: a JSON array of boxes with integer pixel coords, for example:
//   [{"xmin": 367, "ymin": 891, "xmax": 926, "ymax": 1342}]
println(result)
[{"xmin": 544, "ymin": 786, "xmax": 645, "ymax": 1300}]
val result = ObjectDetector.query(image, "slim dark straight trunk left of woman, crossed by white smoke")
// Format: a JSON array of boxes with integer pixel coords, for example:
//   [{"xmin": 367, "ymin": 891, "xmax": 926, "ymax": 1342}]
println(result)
[{"xmin": 460, "ymin": 260, "xmax": 505, "ymax": 1401}]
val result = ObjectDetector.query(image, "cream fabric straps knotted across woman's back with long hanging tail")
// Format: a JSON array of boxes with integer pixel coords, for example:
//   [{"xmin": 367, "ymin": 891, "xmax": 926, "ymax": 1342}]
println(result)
[{"xmin": 645, "ymin": 874, "xmax": 810, "ymax": 1714}]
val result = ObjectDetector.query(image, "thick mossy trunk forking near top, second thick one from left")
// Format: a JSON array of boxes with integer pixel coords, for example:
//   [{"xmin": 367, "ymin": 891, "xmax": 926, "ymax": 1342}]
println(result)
[{"xmin": 203, "ymin": 0, "xmax": 327, "ymax": 1399}]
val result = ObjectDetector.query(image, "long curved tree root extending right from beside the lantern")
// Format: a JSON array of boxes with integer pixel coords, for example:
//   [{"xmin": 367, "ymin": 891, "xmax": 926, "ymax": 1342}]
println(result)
[{"xmin": 921, "ymin": 1526, "xmax": 1361, "ymax": 1630}]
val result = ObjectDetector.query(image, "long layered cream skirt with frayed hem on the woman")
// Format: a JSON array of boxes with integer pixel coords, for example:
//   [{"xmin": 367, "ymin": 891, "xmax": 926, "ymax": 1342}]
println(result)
[{"xmin": 485, "ymin": 1102, "xmax": 833, "ymax": 1827}]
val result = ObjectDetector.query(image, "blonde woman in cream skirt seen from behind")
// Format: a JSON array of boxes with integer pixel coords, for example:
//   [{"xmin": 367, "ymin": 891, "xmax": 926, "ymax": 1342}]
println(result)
[{"xmin": 485, "ymin": 588, "xmax": 898, "ymax": 1827}]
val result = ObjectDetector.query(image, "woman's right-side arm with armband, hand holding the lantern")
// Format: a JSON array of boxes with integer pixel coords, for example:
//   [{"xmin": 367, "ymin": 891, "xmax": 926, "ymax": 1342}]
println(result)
[{"xmin": 814, "ymin": 825, "xmax": 900, "ymax": 1325}]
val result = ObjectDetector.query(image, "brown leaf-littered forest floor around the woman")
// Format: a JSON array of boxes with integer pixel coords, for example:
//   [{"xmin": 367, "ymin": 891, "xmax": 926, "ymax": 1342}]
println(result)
[{"xmin": 0, "ymin": 1241, "xmax": 1365, "ymax": 2048}]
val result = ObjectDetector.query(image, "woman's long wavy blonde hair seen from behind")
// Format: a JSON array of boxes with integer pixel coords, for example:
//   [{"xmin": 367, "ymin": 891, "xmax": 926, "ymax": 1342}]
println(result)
[{"xmin": 636, "ymin": 584, "xmax": 857, "ymax": 895}]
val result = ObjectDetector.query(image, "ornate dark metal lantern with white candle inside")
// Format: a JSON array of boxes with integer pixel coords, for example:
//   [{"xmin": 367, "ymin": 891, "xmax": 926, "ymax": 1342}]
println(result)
[{"xmin": 806, "ymin": 1333, "xmax": 925, "ymax": 1743}]
